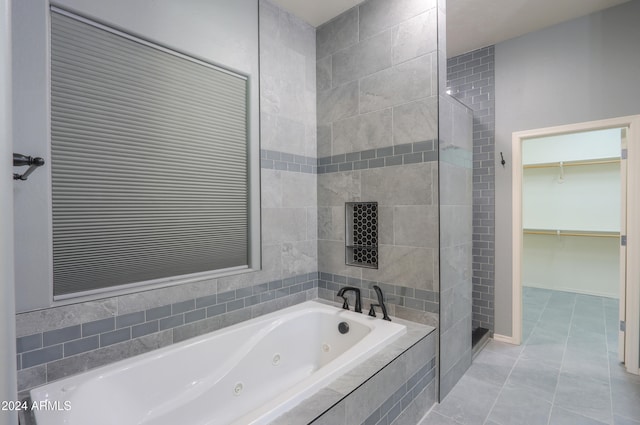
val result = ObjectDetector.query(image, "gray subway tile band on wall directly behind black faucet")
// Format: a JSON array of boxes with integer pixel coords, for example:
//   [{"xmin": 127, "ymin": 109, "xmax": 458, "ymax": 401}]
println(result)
[{"xmin": 318, "ymin": 272, "xmax": 440, "ymax": 313}]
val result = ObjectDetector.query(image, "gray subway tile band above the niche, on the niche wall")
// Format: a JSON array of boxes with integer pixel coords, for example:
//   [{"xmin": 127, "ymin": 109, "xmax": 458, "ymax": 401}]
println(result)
[{"xmin": 318, "ymin": 140, "xmax": 438, "ymax": 174}]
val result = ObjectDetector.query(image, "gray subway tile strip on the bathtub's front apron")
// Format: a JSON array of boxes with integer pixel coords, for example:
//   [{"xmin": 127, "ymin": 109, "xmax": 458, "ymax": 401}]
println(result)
[{"xmin": 361, "ymin": 357, "xmax": 436, "ymax": 425}]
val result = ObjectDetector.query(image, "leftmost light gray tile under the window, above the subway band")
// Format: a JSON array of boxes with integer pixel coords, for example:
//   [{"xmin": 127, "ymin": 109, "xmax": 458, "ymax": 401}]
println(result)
[{"xmin": 16, "ymin": 297, "xmax": 118, "ymax": 338}]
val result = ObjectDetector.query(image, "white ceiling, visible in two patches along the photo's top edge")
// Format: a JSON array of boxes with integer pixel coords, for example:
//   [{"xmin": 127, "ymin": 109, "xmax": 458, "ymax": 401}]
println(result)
[{"xmin": 272, "ymin": 0, "xmax": 629, "ymax": 57}]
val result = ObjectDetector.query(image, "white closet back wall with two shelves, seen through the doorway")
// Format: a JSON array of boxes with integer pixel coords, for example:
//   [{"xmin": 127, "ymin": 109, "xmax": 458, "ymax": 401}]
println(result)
[{"xmin": 522, "ymin": 129, "xmax": 621, "ymax": 298}]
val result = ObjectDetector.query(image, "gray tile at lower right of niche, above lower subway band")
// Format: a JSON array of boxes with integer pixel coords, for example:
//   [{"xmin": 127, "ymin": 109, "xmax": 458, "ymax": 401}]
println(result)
[{"xmin": 362, "ymin": 245, "xmax": 437, "ymax": 291}]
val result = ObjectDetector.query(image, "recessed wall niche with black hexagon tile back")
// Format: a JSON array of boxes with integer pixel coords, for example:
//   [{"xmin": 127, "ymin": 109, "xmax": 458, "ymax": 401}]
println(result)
[{"xmin": 345, "ymin": 202, "xmax": 379, "ymax": 269}]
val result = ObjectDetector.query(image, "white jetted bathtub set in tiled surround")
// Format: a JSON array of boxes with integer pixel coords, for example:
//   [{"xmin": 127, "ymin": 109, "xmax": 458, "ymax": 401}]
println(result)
[{"xmin": 30, "ymin": 301, "xmax": 406, "ymax": 425}]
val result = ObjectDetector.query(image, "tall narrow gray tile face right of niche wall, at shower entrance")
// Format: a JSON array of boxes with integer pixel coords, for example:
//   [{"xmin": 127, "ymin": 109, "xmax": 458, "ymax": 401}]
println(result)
[{"xmin": 439, "ymin": 95, "xmax": 473, "ymax": 400}]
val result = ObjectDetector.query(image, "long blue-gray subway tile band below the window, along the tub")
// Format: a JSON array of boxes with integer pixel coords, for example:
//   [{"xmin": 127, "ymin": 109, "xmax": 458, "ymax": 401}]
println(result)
[{"xmin": 16, "ymin": 272, "xmax": 318, "ymax": 370}]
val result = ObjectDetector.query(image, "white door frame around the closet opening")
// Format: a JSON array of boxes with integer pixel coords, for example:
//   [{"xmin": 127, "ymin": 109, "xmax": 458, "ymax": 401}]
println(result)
[{"xmin": 511, "ymin": 115, "xmax": 640, "ymax": 375}]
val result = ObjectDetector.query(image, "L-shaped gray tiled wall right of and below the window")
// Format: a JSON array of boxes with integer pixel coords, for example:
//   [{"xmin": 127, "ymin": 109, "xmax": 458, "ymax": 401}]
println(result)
[{"xmin": 16, "ymin": 1, "xmax": 318, "ymax": 391}]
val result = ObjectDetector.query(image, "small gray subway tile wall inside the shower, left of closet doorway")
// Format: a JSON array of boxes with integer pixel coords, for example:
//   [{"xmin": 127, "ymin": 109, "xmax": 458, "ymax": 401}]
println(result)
[{"xmin": 447, "ymin": 46, "xmax": 495, "ymax": 332}]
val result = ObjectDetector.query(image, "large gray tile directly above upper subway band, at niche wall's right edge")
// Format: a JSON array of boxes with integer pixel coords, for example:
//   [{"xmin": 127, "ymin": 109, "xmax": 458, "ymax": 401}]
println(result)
[{"xmin": 393, "ymin": 96, "xmax": 438, "ymax": 145}]
